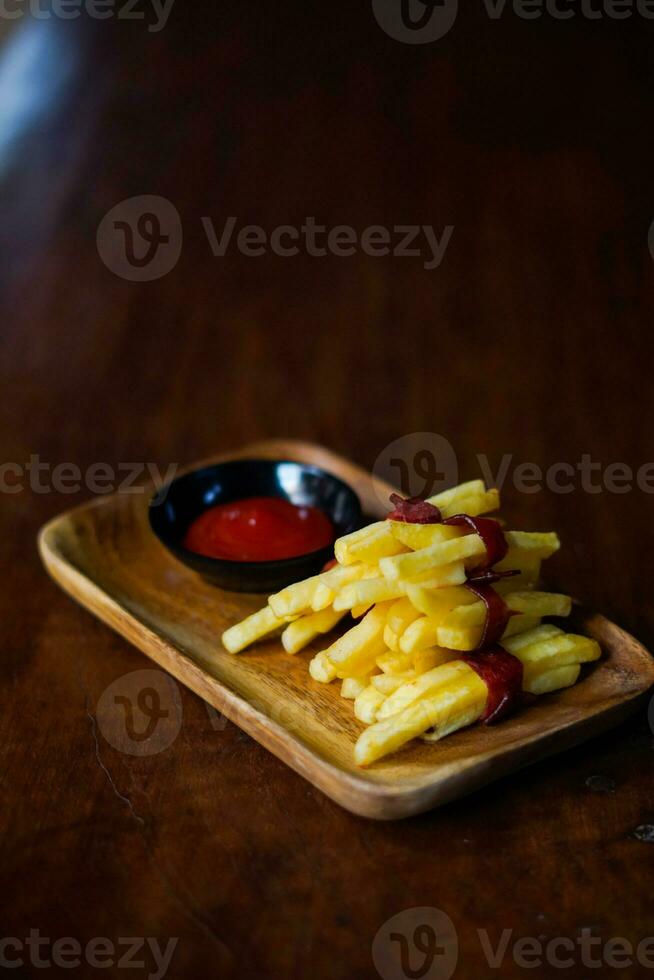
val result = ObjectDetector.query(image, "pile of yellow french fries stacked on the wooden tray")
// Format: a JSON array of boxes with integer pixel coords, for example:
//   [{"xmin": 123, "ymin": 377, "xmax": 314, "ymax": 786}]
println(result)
[{"xmin": 222, "ymin": 480, "xmax": 600, "ymax": 766}]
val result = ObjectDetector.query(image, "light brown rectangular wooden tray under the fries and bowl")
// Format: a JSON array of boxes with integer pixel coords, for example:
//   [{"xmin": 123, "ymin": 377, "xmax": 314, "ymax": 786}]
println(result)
[{"xmin": 39, "ymin": 440, "xmax": 654, "ymax": 819}]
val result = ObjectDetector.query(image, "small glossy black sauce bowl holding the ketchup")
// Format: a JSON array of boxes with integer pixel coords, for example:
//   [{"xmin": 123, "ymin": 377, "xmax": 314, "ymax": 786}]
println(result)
[{"xmin": 149, "ymin": 459, "xmax": 361, "ymax": 592}]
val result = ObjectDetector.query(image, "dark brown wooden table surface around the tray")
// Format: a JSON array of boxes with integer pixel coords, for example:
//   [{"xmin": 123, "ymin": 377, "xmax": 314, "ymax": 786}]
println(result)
[{"xmin": 0, "ymin": 0, "xmax": 654, "ymax": 980}]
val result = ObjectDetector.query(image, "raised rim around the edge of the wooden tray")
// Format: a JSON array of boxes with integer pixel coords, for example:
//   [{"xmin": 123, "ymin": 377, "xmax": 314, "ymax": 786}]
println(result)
[{"xmin": 37, "ymin": 439, "xmax": 654, "ymax": 820}]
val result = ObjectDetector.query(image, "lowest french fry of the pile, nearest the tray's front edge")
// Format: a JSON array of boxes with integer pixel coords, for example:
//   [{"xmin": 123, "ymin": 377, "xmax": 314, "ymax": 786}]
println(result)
[{"xmin": 354, "ymin": 661, "xmax": 488, "ymax": 766}]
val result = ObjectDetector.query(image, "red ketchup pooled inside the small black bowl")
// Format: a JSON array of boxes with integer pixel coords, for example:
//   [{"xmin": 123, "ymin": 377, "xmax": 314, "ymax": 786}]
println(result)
[{"xmin": 184, "ymin": 497, "xmax": 335, "ymax": 561}]
